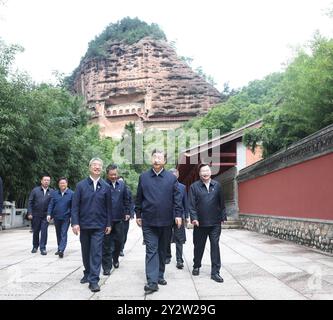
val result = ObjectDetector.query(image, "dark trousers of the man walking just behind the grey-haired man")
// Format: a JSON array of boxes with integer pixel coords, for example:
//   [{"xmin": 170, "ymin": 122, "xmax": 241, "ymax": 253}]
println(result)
[{"xmin": 102, "ymin": 221, "xmax": 124, "ymax": 271}]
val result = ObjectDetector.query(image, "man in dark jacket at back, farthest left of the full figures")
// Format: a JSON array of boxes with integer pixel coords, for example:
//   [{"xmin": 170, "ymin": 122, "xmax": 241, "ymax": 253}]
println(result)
[{"xmin": 28, "ymin": 175, "xmax": 53, "ymax": 255}]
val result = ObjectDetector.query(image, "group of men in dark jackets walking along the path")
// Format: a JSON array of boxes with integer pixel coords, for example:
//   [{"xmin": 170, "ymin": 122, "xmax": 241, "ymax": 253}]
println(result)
[{"xmin": 0, "ymin": 150, "xmax": 227, "ymax": 293}]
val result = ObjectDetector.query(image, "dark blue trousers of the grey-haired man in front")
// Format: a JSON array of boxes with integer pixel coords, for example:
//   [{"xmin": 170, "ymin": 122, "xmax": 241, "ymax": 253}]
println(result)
[{"xmin": 80, "ymin": 229, "xmax": 105, "ymax": 284}]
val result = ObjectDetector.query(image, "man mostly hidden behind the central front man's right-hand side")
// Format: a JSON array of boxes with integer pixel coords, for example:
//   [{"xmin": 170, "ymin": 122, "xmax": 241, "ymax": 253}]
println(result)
[{"xmin": 165, "ymin": 169, "xmax": 189, "ymax": 269}]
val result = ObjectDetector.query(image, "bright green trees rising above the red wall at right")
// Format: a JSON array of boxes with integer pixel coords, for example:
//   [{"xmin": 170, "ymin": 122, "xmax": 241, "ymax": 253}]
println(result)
[{"xmin": 245, "ymin": 34, "xmax": 333, "ymax": 156}]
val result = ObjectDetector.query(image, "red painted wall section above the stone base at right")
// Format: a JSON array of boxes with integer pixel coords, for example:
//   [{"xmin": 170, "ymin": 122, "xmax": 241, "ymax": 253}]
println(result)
[{"xmin": 238, "ymin": 153, "xmax": 333, "ymax": 220}]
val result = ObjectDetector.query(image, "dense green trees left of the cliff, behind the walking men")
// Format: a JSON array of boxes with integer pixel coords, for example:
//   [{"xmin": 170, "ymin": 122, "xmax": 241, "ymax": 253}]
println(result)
[{"xmin": 0, "ymin": 42, "xmax": 116, "ymax": 205}]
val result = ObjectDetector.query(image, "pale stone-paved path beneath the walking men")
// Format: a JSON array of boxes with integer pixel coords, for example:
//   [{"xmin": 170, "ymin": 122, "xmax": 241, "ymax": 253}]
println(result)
[{"xmin": 0, "ymin": 221, "xmax": 333, "ymax": 300}]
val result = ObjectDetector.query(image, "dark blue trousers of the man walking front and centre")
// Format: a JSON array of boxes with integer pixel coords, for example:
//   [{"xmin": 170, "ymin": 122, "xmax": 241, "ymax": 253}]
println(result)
[{"xmin": 142, "ymin": 226, "xmax": 171, "ymax": 284}]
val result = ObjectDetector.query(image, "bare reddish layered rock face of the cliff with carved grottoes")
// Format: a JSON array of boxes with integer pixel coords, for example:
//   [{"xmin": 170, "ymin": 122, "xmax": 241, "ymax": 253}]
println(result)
[{"xmin": 74, "ymin": 38, "xmax": 221, "ymax": 137}]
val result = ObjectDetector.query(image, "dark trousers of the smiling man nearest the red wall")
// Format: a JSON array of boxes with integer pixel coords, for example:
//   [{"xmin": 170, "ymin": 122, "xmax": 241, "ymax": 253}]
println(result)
[{"xmin": 193, "ymin": 225, "xmax": 221, "ymax": 275}]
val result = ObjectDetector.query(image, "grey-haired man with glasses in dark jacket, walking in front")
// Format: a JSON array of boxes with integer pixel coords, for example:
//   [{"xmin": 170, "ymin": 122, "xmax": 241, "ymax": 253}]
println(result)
[{"xmin": 71, "ymin": 158, "xmax": 112, "ymax": 292}]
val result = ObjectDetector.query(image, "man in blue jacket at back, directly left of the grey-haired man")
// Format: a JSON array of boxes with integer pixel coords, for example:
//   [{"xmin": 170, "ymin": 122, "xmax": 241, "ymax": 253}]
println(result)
[{"xmin": 47, "ymin": 177, "xmax": 74, "ymax": 258}]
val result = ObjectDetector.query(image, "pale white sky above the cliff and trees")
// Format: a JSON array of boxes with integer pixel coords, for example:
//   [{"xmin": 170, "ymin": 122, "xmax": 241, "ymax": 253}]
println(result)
[{"xmin": 0, "ymin": 0, "xmax": 333, "ymax": 90}]
